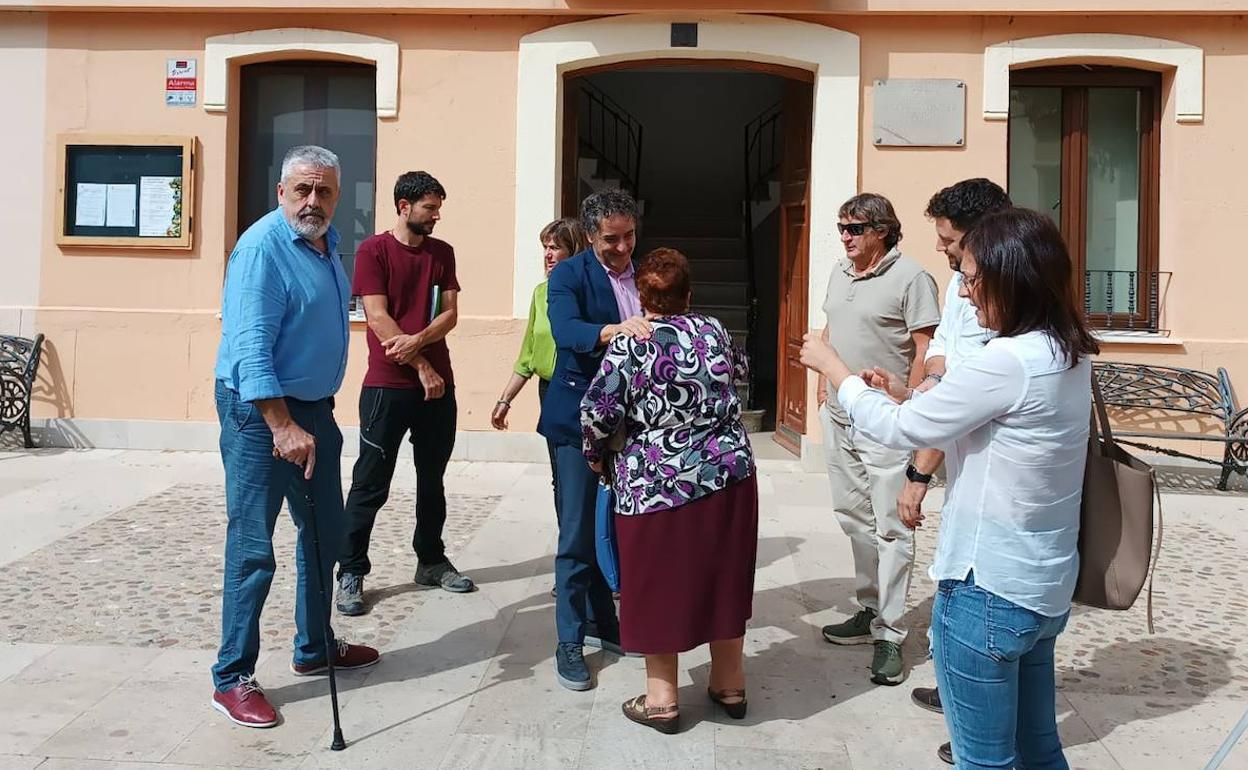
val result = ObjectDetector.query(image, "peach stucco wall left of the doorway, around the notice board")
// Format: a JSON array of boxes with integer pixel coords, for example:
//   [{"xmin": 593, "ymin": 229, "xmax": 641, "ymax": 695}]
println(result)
[{"xmin": 29, "ymin": 15, "xmax": 559, "ymax": 429}]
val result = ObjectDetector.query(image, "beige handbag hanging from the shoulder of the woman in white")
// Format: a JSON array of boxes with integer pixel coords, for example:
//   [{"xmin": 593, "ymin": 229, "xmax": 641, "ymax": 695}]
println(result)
[{"xmin": 1075, "ymin": 376, "xmax": 1162, "ymax": 634}]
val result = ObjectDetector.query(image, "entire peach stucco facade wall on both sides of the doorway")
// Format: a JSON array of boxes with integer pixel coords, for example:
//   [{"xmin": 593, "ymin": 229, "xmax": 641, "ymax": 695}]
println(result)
[{"xmin": 17, "ymin": 12, "xmax": 1248, "ymax": 449}]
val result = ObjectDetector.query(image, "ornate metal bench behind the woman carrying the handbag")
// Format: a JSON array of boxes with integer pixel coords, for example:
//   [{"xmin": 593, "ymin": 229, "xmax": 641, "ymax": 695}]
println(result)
[{"xmin": 1092, "ymin": 361, "xmax": 1248, "ymax": 489}]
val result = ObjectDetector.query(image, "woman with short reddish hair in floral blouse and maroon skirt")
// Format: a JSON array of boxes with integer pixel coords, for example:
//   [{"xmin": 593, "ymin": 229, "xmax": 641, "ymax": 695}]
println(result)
[{"xmin": 580, "ymin": 248, "xmax": 759, "ymax": 733}]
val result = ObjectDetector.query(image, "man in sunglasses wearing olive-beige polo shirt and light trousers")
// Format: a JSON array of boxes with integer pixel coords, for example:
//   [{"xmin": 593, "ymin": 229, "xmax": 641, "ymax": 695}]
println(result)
[{"xmin": 819, "ymin": 192, "xmax": 940, "ymax": 685}]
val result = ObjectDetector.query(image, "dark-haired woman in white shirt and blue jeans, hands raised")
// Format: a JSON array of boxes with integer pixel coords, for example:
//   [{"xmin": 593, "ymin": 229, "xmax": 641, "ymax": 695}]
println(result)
[{"xmin": 801, "ymin": 208, "xmax": 1097, "ymax": 770}]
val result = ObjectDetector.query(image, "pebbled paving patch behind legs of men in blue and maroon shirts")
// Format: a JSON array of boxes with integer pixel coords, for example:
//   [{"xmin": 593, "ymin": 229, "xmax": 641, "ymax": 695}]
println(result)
[{"xmin": 0, "ymin": 484, "xmax": 499, "ymax": 649}]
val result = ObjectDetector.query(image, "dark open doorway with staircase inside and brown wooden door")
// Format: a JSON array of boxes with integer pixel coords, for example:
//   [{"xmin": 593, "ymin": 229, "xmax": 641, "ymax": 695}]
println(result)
[{"xmin": 562, "ymin": 60, "xmax": 812, "ymax": 453}]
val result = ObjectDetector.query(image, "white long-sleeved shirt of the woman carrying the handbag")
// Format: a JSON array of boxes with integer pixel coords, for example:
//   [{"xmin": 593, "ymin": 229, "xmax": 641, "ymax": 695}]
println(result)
[{"xmin": 837, "ymin": 332, "xmax": 1092, "ymax": 618}]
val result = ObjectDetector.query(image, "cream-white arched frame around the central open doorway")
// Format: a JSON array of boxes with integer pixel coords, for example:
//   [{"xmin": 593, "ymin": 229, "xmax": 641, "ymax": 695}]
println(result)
[{"xmin": 512, "ymin": 14, "xmax": 860, "ymax": 327}]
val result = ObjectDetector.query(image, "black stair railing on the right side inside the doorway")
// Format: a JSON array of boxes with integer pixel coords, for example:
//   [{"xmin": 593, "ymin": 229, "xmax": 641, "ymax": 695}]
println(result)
[{"xmin": 741, "ymin": 102, "xmax": 782, "ymax": 409}]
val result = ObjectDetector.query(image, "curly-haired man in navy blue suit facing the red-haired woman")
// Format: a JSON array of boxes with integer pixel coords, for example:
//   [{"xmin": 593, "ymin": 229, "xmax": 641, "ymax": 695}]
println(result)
[{"xmin": 538, "ymin": 190, "xmax": 650, "ymax": 690}]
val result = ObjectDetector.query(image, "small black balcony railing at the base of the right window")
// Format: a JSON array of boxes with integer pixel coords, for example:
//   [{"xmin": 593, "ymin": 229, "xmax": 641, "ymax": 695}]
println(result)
[{"xmin": 1083, "ymin": 270, "xmax": 1173, "ymax": 332}]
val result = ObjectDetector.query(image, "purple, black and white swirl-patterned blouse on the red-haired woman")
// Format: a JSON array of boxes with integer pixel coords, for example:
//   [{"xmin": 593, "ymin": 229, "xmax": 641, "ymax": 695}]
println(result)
[{"xmin": 580, "ymin": 313, "xmax": 754, "ymax": 515}]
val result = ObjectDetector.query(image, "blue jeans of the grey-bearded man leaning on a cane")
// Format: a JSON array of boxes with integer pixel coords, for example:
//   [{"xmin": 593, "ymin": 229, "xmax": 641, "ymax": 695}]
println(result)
[{"xmin": 212, "ymin": 381, "xmax": 346, "ymax": 691}]
